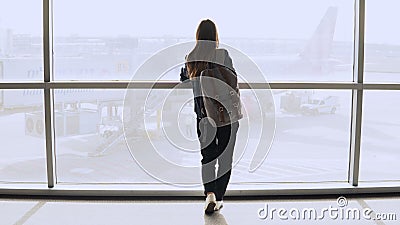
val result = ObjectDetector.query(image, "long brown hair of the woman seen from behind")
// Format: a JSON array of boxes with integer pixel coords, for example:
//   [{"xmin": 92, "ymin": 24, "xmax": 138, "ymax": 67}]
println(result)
[{"xmin": 186, "ymin": 19, "xmax": 219, "ymax": 78}]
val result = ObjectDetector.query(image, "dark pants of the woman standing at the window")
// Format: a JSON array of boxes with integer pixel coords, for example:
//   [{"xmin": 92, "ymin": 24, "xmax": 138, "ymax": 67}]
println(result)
[{"xmin": 197, "ymin": 119, "xmax": 239, "ymax": 201}]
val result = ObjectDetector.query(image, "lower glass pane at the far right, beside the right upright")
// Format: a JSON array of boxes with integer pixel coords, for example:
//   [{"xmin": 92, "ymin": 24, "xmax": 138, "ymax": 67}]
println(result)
[{"xmin": 360, "ymin": 91, "xmax": 400, "ymax": 181}]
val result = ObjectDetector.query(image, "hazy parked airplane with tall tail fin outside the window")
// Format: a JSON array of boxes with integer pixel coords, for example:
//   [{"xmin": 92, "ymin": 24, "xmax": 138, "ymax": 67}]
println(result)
[{"xmin": 250, "ymin": 7, "xmax": 348, "ymax": 80}]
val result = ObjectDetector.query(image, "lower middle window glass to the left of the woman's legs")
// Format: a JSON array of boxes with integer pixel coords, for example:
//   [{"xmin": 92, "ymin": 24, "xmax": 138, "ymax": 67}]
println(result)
[{"xmin": 55, "ymin": 89, "xmax": 216, "ymax": 184}]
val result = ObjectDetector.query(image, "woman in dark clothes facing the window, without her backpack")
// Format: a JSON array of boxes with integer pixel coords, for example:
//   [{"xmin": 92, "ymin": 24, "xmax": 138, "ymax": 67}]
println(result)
[{"xmin": 181, "ymin": 19, "xmax": 239, "ymax": 214}]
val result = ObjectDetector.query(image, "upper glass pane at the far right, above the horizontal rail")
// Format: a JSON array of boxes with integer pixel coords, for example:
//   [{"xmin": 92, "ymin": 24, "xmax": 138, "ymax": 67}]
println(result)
[{"xmin": 364, "ymin": 0, "xmax": 400, "ymax": 83}]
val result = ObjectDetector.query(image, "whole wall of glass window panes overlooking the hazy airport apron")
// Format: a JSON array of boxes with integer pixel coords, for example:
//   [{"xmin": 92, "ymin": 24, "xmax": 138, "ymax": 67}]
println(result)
[{"xmin": 0, "ymin": 0, "xmax": 400, "ymax": 192}]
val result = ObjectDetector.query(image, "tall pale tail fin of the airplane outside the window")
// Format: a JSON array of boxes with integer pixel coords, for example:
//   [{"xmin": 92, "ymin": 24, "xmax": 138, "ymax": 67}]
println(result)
[{"xmin": 300, "ymin": 6, "xmax": 338, "ymax": 60}]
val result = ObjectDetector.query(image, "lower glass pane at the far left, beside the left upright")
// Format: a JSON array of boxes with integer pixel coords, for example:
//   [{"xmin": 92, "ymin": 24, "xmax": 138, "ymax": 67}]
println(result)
[{"xmin": 0, "ymin": 90, "xmax": 47, "ymax": 183}]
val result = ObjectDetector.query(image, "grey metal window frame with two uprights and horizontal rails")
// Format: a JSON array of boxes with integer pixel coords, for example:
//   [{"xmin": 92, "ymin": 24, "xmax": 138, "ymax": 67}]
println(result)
[{"xmin": 0, "ymin": 0, "xmax": 400, "ymax": 196}]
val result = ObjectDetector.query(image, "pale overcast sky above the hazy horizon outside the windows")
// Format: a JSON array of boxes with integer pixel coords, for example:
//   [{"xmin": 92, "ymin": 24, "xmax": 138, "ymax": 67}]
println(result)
[{"xmin": 0, "ymin": 0, "xmax": 400, "ymax": 44}]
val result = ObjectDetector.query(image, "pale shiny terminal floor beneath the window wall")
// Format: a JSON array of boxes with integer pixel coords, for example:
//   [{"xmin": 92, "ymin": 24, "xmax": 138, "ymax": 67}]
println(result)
[{"xmin": 0, "ymin": 197, "xmax": 400, "ymax": 225}]
